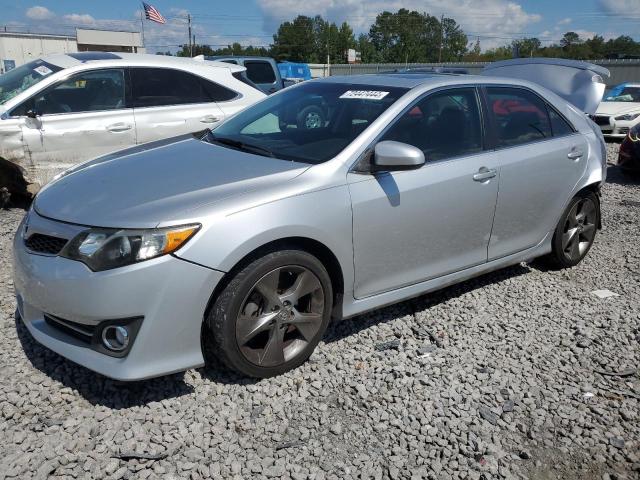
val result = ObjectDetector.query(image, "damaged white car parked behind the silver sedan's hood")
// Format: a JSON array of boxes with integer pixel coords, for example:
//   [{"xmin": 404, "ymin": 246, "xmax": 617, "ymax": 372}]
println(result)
[{"xmin": 0, "ymin": 52, "xmax": 265, "ymax": 188}]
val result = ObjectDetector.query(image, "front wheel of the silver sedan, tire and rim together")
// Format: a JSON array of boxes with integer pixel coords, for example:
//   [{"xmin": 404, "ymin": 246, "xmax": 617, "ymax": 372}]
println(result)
[{"xmin": 203, "ymin": 249, "xmax": 333, "ymax": 378}]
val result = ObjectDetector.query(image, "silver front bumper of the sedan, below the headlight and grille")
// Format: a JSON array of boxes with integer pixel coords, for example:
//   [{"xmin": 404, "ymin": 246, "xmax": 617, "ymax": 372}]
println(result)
[{"xmin": 13, "ymin": 217, "xmax": 224, "ymax": 380}]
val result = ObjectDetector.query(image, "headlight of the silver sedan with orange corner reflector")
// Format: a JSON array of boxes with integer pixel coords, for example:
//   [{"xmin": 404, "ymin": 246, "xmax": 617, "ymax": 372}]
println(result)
[{"xmin": 60, "ymin": 225, "xmax": 200, "ymax": 272}]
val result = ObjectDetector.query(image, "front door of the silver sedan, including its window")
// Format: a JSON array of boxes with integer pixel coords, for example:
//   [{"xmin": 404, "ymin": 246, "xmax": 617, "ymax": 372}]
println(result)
[{"xmin": 348, "ymin": 87, "xmax": 499, "ymax": 298}]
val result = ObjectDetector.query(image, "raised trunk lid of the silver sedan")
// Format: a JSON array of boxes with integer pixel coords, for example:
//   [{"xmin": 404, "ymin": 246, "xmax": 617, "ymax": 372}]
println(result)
[{"xmin": 482, "ymin": 58, "xmax": 611, "ymax": 114}]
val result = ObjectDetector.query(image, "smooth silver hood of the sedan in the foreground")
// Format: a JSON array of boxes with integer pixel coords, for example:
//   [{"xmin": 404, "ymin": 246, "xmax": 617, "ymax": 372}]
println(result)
[{"xmin": 34, "ymin": 136, "xmax": 309, "ymax": 228}]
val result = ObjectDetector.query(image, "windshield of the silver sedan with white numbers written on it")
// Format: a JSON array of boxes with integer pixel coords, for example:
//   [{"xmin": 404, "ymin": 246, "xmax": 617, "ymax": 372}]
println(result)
[{"xmin": 203, "ymin": 82, "xmax": 407, "ymax": 164}]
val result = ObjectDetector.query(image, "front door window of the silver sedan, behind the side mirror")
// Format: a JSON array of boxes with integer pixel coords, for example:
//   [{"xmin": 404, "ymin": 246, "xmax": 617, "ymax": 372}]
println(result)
[{"xmin": 381, "ymin": 88, "xmax": 482, "ymax": 162}]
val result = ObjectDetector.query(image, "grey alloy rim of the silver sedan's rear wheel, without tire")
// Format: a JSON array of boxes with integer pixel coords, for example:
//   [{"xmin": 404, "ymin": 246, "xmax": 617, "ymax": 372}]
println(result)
[{"xmin": 562, "ymin": 197, "xmax": 598, "ymax": 262}]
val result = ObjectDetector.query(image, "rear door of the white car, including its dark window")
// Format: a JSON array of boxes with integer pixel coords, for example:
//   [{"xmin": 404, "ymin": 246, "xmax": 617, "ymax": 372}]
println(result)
[{"xmin": 130, "ymin": 67, "xmax": 228, "ymax": 143}]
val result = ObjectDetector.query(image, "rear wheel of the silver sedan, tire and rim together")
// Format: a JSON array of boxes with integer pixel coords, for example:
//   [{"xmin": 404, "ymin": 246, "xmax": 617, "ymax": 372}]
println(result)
[{"xmin": 543, "ymin": 191, "xmax": 600, "ymax": 269}]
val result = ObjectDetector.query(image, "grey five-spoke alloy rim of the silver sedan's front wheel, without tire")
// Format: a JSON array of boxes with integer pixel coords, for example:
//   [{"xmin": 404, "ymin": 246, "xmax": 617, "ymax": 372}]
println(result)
[{"xmin": 236, "ymin": 265, "xmax": 325, "ymax": 367}]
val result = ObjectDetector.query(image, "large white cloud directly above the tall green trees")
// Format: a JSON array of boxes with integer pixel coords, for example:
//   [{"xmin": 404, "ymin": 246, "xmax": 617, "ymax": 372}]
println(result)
[{"xmin": 257, "ymin": 0, "xmax": 542, "ymax": 48}]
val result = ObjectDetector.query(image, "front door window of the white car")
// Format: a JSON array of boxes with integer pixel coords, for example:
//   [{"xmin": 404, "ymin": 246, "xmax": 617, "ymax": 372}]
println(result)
[{"xmin": 33, "ymin": 69, "xmax": 125, "ymax": 115}]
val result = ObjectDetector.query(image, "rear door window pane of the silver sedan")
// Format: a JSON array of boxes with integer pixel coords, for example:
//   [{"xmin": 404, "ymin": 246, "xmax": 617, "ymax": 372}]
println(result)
[{"xmin": 487, "ymin": 87, "xmax": 552, "ymax": 147}]
